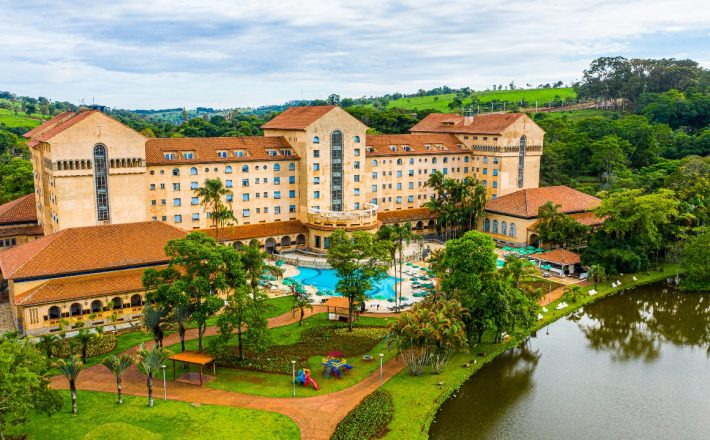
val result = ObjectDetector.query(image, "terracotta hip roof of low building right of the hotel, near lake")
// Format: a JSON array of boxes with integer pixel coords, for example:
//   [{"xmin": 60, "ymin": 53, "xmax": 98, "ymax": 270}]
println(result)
[{"xmin": 486, "ymin": 185, "xmax": 601, "ymax": 218}]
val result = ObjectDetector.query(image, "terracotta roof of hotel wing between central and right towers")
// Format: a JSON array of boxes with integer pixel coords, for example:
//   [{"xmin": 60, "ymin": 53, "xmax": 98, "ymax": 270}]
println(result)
[{"xmin": 365, "ymin": 134, "xmax": 472, "ymax": 156}]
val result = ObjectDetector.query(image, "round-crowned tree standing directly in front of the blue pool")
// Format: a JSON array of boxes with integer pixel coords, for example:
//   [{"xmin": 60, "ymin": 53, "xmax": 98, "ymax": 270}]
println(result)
[{"xmin": 327, "ymin": 229, "xmax": 390, "ymax": 331}]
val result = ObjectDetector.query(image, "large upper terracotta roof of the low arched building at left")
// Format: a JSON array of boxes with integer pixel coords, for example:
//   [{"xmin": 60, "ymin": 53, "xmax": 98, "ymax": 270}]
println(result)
[{"xmin": 0, "ymin": 222, "xmax": 187, "ymax": 279}]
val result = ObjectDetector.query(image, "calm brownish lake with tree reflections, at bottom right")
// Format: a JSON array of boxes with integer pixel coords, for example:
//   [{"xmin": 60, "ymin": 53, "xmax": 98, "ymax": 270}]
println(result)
[{"xmin": 429, "ymin": 285, "xmax": 710, "ymax": 439}]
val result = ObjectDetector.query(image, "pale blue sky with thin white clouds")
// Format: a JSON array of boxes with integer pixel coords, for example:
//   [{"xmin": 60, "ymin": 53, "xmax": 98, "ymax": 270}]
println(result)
[{"xmin": 0, "ymin": 0, "xmax": 710, "ymax": 109}]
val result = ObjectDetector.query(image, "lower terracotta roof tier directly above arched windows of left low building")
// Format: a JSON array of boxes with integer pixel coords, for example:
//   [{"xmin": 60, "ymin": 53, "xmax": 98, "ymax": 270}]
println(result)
[{"xmin": 15, "ymin": 268, "xmax": 155, "ymax": 306}]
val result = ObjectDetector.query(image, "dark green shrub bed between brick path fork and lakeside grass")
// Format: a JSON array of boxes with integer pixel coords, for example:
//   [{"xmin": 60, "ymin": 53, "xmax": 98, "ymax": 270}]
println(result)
[{"xmin": 331, "ymin": 390, "xmax": 394, "ymax": 440}]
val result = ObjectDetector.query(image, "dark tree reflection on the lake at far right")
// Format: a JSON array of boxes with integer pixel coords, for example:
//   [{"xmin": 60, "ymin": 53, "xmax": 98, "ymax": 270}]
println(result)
[{"xmin": 578, "ymin": 286, "xmax": 710, "ymax": 362}]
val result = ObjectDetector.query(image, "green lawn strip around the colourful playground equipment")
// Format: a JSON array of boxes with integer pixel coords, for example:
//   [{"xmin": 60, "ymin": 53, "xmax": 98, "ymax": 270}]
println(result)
[{"xmin": 207, "ymin": 341, "xmax": 396, "ymax": 397}]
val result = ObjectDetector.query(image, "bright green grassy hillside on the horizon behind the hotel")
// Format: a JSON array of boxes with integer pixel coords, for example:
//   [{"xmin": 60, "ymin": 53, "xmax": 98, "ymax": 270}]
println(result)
[{"xmin": 387, "ymin": 87, "xmax": 576, "ymax": 113}]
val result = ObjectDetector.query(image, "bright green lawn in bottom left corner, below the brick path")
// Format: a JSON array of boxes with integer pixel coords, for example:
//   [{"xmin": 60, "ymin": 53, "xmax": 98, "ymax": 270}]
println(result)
[{"xmin": 11, "ymin": 390, "xmax": 300, "ymax": 440}]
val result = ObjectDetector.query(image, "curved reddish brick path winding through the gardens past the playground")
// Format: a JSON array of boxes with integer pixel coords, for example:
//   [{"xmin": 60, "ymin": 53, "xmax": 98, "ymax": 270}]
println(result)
[{"xmin": 52, "ymin": 305, "xmax": 404, "ymax": 440}]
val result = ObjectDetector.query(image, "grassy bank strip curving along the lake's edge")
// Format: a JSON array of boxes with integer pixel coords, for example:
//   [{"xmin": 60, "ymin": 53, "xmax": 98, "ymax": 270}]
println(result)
[{"xmin": 384, "ymin": 265, "xmax": 683, "ymax": 439}]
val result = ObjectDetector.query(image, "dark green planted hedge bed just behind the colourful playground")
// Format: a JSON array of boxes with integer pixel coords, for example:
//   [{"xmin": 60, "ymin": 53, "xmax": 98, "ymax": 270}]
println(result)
[{"xmin": 213, "ymin": 327, "xmax": 387, "ymax": 374}]
